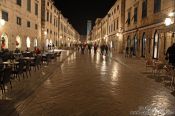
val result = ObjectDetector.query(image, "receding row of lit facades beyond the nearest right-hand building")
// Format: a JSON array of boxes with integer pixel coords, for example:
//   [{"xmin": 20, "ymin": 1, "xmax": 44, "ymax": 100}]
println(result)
[{"xmin": 91, "ymin": 0, "xmax": 125, "ymax": 53}]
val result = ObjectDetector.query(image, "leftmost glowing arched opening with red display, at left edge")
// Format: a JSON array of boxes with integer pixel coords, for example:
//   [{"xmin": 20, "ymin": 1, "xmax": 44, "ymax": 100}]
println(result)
[{"xmin": 1, "ymin": 33, "xmax": 8, "ymax": 49}]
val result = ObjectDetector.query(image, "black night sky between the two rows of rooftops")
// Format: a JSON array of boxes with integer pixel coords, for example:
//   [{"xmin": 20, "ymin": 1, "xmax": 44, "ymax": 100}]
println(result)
[{"xmin": 55, "ymin": 0, "xmax": 116, "ymax": 35}]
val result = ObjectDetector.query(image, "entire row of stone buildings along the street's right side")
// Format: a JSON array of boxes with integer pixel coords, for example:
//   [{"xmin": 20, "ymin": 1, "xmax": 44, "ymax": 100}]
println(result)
[{"xmin": 90, "ymin": 0, "xmax": 175, "ymax": 59}]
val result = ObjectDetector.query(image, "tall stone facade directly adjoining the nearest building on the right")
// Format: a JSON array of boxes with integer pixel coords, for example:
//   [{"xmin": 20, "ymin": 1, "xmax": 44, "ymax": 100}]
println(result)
[{"xmin": 107, "ymin": 0, "xmax": 125, "ymax": 53}]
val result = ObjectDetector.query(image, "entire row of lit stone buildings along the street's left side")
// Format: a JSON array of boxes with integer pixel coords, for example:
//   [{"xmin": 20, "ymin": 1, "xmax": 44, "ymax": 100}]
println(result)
[{"xmin": 0, "ymin": 0, "xmax": 80, "ymax": 50}]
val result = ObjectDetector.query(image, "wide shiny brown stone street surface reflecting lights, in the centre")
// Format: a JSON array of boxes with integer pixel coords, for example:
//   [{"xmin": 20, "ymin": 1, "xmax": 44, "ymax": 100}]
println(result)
[{"xmin": 17, "ymin": 53, "xmax": 175, "ymax": 116}]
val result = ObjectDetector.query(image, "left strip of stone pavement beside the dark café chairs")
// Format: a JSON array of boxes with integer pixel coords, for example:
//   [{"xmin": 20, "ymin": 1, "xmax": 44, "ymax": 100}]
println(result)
[{"xmin": 0, "ymin": 50, "xmax": 73, "ymax": 116}]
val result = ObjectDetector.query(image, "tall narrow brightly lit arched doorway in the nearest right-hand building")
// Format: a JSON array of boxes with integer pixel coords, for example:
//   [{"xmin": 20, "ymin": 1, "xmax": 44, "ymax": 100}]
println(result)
[{"xmin": 153, "ymin": 31, "xmax": 159, "ymax": 59}]
